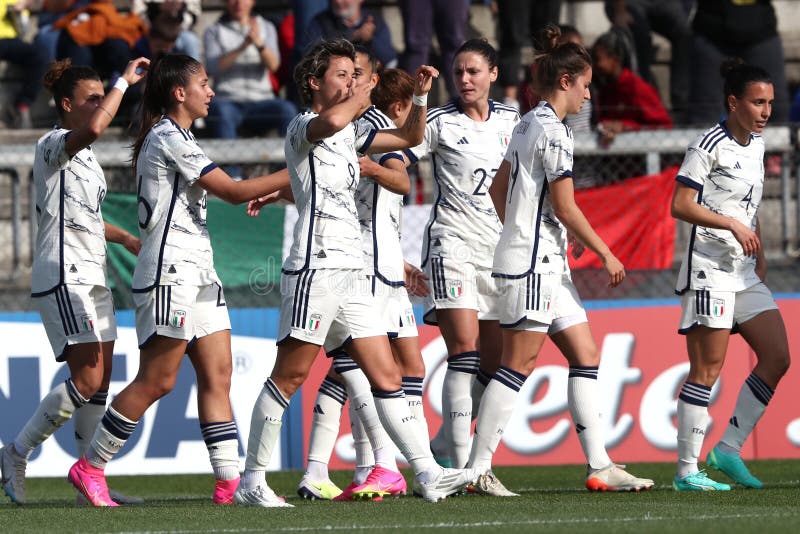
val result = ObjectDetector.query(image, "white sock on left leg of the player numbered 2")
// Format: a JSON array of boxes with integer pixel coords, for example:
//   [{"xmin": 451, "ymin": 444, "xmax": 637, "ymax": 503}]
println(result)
[{"xmin": 442, "ymin": 352, "xmax": 480, "ymax": 468}]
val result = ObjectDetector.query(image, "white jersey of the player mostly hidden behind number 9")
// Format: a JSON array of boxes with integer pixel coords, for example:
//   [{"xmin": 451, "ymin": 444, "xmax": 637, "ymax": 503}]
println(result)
[{"xmin": 356, "ymin": 106, "xmax": 405, "ymax": 286}]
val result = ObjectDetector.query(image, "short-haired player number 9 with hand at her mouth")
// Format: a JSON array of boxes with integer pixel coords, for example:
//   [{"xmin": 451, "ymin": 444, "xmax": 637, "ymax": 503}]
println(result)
[{"xmin": 235, "ymin": 39, "xmax": 472, "ymax": 507}]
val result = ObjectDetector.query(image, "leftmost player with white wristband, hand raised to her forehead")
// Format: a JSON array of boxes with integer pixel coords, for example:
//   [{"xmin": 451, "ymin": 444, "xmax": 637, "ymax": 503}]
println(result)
[{"xmin": 0, "ymin": 58, "xmax": 149, "ymax": 503}]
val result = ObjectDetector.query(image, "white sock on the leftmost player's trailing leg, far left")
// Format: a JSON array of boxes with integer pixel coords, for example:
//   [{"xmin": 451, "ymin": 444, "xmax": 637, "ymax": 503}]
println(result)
[{"xmin": 14, "ymin": 378, "xmax": 89, "ymax": 458}]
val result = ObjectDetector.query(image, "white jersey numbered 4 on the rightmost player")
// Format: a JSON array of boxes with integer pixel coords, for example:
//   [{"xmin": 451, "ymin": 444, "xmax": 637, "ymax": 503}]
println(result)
[{"xmin": 675, "ymin": 123, "xmax": 764, "ymax": 294}]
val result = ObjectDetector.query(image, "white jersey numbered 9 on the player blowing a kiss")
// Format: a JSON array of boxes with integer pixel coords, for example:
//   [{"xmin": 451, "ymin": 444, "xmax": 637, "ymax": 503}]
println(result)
[{"xmin": 283, "ymin": 112, "xmax": 377, "ymax": 274}]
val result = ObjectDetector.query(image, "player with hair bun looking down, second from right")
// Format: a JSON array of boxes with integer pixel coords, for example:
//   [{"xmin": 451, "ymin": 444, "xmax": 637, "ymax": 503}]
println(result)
[{"xmin": 468, "ymin": 25, "xmax": 653, "ymax": 491}]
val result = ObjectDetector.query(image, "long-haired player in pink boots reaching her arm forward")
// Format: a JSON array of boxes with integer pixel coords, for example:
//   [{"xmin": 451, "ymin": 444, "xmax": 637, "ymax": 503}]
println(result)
[{"xmin": 69, "ymin": 55, "xmax": 286, "ymax": 506}]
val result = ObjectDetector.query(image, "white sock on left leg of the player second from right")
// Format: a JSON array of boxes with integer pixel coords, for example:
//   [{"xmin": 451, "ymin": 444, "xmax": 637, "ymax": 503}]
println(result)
[{"xmin": 467, "ymin": 366, "xmax": 526, "ymax": 473}]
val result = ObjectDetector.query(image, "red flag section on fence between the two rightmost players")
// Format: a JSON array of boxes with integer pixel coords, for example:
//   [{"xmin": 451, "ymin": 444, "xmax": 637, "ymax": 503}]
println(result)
[{"xmin": 569, "ymin": 167, "xmax": 678, "ymax": 269}]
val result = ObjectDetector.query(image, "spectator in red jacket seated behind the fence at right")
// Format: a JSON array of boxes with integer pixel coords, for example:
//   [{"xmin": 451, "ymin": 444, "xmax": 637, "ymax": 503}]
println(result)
[{"xmin": 592, "ymin": 28, "xmax": 672, "ymax": 148}]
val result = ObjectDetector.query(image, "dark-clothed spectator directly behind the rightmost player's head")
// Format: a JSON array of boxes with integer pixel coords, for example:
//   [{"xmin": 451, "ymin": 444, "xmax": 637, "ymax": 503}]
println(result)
[{"xmin": 689, "ymin": 0, "xmax": 789, "ymax": 122}]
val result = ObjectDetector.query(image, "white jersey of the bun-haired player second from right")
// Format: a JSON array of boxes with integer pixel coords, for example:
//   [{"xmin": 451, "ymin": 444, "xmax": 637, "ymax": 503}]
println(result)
[{"xmin": 492, "ymin": 102, "xmax": 574, "ymax": 278}]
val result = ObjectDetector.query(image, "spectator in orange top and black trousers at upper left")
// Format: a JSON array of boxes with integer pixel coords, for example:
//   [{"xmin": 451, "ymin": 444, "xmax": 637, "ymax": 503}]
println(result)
[{"xmin": 53, "ymin": 0, "xmax": 146, "ymax": 81}]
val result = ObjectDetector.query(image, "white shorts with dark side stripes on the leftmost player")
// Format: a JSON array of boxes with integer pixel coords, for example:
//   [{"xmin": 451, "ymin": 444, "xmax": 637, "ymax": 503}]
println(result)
[{"xmin": 33, "ymin": 284, "xmax": 117, "ymax": 362}]
